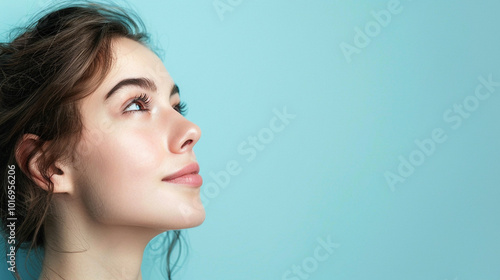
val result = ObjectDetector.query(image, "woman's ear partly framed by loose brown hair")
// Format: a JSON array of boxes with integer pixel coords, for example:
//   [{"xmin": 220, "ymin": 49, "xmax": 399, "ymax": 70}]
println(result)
[{"xmin": 16, "ymin": 133, "xmax": 73, "ymax": 193}]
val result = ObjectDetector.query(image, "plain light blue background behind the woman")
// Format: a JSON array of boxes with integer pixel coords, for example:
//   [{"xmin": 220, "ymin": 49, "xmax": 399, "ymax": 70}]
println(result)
[{"xmin": 0, "ymin": 0, "xmax": 500, "ymax": 280}]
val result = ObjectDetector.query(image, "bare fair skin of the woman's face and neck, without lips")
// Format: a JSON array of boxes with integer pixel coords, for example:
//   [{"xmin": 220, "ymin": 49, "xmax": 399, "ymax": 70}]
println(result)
[{"xmin": 22, "ymin": 38, "xmax": 205, "ymax": 280}]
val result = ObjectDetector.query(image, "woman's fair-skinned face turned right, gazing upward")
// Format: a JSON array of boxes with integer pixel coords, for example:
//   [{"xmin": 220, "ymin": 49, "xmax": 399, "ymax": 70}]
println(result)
[{"xmin": 71, "ymin": 38, "xmax": 205, "ymax": 231}]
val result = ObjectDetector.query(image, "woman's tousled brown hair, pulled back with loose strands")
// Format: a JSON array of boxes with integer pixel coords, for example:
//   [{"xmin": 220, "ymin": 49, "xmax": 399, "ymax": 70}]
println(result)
[{"xmin": 0, "ymin": 2, "xmax": 184, "ymax": 279}]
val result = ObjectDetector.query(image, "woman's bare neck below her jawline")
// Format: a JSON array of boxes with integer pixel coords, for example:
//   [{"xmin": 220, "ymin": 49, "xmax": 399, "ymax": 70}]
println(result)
[{"xmin": 40, "ymin": 198, "xmax": 160, "ymax": 280}]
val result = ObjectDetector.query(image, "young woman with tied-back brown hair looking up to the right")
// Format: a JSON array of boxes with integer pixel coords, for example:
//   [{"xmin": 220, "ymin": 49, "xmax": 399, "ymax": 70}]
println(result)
[{"xmin": 0, "ymin": 3, "xmax": 205, "ymax": 280}]
